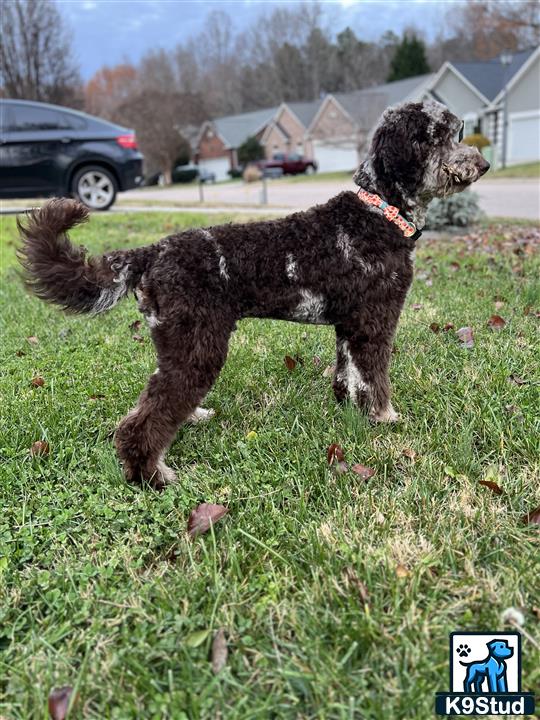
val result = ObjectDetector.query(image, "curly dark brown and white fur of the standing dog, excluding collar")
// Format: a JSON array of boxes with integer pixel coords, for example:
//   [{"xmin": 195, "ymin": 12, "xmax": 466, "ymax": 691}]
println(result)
[{"xmin": 16, "ymin": 103, "xmax": 489, "ymax": 488}]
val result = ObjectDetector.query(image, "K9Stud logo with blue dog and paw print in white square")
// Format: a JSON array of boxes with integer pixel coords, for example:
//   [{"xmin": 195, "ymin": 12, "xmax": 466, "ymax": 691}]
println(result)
[{"xmin": 435, "ymin": 632, "xmax": 534, "ymax": 716}]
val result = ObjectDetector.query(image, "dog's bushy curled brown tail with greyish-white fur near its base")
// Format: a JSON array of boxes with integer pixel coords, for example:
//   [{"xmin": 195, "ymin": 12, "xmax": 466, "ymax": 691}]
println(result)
[{"xmin": 17, "ymin": 198, "xmax": 147, "ymax": 314}]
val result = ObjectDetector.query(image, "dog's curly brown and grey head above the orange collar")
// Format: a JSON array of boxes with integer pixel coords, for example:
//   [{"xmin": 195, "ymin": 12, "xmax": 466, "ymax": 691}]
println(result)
[{"xmin": 354, "ymin": 101, "xmax": 489, "ymax": 204}]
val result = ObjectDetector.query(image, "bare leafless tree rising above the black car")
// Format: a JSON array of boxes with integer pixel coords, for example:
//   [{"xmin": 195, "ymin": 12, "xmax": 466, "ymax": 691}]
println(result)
[{"xmin": 0, "ymin": 0, "xmax": 81, "ymax": 105}]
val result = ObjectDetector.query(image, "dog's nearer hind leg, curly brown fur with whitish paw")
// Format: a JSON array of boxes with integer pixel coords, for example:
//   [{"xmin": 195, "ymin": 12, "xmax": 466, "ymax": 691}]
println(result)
[{"xmin": 115, "ymin": 313, "xmax": 234, "ymax": 489}]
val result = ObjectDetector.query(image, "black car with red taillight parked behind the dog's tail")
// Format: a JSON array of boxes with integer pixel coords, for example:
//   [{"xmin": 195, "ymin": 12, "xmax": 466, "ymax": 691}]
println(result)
[{"xmin": 0, "ymin": 100, "xmax": 143, "ymax": 210}]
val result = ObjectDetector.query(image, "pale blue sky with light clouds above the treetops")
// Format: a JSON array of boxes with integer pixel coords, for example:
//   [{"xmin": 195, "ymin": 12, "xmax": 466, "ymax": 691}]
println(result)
[{"xmin": 57, "ymin": 0, "xmax": 456, "ymax": 80}]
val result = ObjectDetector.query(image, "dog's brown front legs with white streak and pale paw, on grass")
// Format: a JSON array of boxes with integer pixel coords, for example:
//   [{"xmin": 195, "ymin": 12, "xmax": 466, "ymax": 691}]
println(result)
[{"xmin": 333, "ymin": 326, "xmax": 398, "ymax": 422}]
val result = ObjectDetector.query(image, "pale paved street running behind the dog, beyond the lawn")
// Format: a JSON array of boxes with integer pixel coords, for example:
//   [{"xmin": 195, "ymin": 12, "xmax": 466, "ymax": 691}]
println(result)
[{"xmin": 119, "ymin": 178, "xmax": 540, "ymax": 219}]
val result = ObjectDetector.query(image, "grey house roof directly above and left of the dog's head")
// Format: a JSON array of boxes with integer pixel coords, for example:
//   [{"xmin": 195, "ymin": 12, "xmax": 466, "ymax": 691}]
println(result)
[{"xmin": 333, "ymin": 74, "xmax": 433, "ymax": 129}]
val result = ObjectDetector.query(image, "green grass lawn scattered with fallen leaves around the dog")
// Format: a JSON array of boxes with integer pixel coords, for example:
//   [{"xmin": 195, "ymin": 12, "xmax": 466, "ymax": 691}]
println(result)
[{"xmin": 0, "ymin": 207, "xmax": 540, "ymax": 720}]
